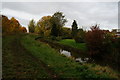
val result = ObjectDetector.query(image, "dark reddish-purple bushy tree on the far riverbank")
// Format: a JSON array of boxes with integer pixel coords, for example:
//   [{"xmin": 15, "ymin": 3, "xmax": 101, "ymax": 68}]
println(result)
[{"xmin": 86, "ymin": 25, "xmax": 104, "ymax": 58}]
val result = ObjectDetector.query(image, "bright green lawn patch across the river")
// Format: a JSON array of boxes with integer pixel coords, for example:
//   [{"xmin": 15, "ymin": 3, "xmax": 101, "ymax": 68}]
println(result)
[{"xmin": 59, "ymin": 39, "xmax": 87, "ymax": 51}]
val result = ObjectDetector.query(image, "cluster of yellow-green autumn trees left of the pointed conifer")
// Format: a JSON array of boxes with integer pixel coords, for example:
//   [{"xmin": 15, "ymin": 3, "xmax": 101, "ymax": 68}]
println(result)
[{"xmin": 28, "ymin": 12, "xmax": 70, "ymax": 37}]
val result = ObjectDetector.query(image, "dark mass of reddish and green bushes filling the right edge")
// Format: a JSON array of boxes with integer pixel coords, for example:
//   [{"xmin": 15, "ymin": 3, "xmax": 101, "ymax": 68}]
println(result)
[{"xmin": 85, "ymin": 25, "xmax": 120, "ymax": 64}]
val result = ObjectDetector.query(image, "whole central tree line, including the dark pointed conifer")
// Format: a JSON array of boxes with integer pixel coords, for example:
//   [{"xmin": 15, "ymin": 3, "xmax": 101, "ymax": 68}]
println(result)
[{"xmin": 28, "ymin": 12, "xmax": 85, "ymax": 42}]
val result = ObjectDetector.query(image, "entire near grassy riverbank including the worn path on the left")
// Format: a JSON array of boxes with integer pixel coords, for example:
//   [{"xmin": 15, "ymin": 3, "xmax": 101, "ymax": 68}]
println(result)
[{"xmin": 3, "ymin": 34, "xmax": 118, "ymax": 80}]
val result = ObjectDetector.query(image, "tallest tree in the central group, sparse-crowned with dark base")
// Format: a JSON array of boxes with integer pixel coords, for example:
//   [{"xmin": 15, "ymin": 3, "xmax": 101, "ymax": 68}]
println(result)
[{"xmin": 50, "ymin": 12, "xmax": 67, "ymax": 37}]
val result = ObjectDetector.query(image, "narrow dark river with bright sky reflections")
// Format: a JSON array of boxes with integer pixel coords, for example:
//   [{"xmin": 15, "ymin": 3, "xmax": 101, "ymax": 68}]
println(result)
[{"xmin": 37, "ymin": 40, "xmax": 120, "ymax": 71}]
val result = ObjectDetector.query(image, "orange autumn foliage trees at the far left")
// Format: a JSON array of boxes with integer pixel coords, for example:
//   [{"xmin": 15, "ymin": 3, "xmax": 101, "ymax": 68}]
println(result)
[{"xmin": 2, "ymin": 15, "xmax": 27, "ymax": 34}]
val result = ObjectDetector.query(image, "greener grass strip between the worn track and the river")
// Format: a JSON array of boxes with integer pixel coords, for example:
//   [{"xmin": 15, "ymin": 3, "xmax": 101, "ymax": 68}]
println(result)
[{"xmin": 21, "ymin": 35, "xmax": 117, "ymax": 79}]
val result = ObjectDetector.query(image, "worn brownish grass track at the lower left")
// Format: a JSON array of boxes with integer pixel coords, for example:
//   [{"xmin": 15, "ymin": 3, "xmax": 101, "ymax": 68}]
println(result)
[{"xmin": 3, "ymin": 36, "xmax": 56, "ymax": 78}]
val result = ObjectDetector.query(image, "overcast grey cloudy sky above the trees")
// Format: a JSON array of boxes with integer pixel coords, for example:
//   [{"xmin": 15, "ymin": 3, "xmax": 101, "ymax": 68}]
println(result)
[{"xmin": 2, "ymin": 2, "xmax": 118, "ymax": 30}]
